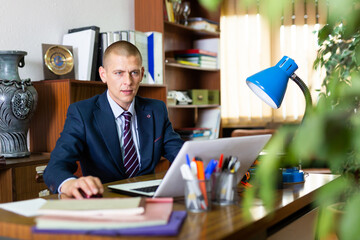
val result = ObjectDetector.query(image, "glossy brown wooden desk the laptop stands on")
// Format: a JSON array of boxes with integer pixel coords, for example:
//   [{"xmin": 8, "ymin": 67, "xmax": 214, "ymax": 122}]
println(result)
[{"xmin": 0, "ymin": 174, "xmax": 337, "ymax": 240}]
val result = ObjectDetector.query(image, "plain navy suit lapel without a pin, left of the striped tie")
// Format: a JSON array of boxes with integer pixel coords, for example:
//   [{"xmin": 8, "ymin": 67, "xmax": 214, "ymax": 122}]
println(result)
[{"xmin": 94, "ymin": 92, "xmax": 125, "ymax": 175}]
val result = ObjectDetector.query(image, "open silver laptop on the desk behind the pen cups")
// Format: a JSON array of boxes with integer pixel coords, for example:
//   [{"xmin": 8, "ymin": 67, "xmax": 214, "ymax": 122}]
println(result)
[{"xmin": 108, "ymin": 134, "xmax": 271, "ymax": 197}]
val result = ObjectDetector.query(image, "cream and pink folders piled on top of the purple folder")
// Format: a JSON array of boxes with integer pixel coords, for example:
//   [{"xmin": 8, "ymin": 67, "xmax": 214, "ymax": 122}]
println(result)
[{"xmin": 36, "ymin": 197, "xmax": 173, "ymax": 230}]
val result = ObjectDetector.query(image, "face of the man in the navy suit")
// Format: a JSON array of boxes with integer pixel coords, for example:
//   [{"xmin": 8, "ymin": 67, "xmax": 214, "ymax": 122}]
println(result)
[{"xmin": 99, "ymin": 53, "xmax": 144, "ymax": 110}]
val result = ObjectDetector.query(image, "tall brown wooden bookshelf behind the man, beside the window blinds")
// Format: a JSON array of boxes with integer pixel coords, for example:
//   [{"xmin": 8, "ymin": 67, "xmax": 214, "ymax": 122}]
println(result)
[{"xmin": 135, "ymin": 0, "xmax": 220, "ymax": 128}]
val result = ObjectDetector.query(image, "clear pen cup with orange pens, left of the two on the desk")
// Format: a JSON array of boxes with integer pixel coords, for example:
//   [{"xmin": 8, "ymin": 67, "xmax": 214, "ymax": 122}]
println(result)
[{"xmin": 185, "ymin": 180, "xmax": 211, "ymax": 212}]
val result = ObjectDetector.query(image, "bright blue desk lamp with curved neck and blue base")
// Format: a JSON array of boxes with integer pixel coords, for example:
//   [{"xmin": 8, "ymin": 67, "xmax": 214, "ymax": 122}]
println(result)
[{"xmin": 246, "ymin": 56, "xmax": 312, "ymax": 183}]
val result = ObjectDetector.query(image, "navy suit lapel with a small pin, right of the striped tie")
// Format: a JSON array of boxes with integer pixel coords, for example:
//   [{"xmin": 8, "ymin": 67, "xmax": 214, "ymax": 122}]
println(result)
[{"xmin": 135, "ymin": 97, "xmax": 155, "ymax": 171}]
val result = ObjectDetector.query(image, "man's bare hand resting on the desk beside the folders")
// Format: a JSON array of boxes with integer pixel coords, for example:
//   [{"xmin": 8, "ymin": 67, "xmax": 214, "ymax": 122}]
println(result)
[{"xmin": 60, "ymin": 176, "xmax": 104, "ymax": 199}]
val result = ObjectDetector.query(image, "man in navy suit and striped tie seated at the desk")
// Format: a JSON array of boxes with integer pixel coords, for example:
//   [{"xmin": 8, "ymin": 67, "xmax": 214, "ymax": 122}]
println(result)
[{"xmin": 44, "ymin": 41, "xmax": 183, "ymax": 199}]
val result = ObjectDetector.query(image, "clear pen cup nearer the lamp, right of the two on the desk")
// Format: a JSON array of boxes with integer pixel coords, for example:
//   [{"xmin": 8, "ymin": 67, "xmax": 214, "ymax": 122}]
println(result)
[{"xmin": 213, "ymin": 172, "xmax": 239, "ymax": 206}]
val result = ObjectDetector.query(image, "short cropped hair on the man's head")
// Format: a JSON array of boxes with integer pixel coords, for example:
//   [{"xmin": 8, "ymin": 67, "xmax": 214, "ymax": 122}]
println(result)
[{"xmin": 103, "ymin": 41, "xmax": 142, "ymax": 67}]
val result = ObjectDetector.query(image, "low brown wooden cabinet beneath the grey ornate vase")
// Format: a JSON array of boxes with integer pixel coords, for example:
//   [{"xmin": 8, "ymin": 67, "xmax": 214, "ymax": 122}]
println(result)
[{"xmin": 0, "ymin": 153, "xmax": 50, "ymax": 203}]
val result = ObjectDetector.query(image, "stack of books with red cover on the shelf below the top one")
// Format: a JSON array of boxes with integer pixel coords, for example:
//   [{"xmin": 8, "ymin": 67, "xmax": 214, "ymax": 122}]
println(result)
[{"xmin": 174, "ymin": 49, "xmax": 217, "ymax": 69}]
